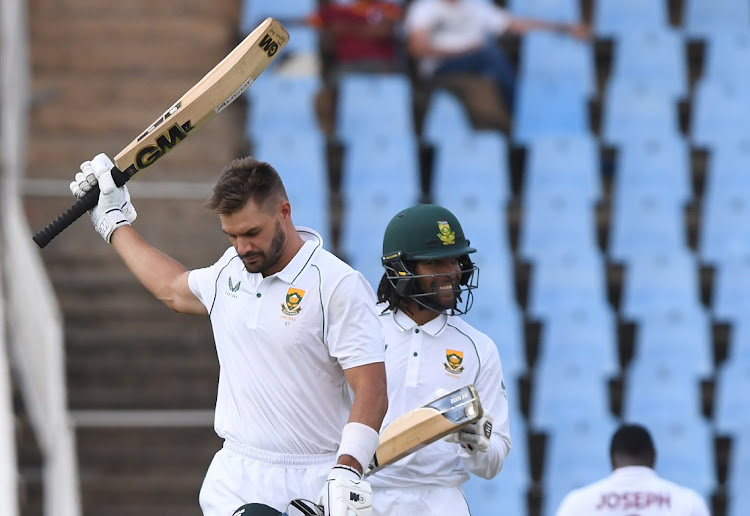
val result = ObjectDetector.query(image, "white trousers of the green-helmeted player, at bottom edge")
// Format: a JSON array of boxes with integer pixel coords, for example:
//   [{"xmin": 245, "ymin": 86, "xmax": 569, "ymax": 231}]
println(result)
[{"xmin": 372, "ymin": 486, "xmax": 469, "ymax": 516}]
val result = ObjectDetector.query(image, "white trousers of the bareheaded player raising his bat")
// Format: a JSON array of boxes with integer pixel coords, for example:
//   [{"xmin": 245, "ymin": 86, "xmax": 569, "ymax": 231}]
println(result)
[{"xmin": 199, "ymin": 441, "xmax": 336, "ymax": 516}]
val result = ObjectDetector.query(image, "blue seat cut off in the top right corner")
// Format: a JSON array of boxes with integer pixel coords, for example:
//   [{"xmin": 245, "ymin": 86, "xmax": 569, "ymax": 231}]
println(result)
[{"xmin": 682, "ymin": 0, "xmax": 750, "ymax": 40}]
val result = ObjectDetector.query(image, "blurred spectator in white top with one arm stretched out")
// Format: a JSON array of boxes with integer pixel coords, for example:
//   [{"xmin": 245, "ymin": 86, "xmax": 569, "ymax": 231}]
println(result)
[{"xmin": 406, "ymin": 0, "xmax": 589, "ymax": 111}]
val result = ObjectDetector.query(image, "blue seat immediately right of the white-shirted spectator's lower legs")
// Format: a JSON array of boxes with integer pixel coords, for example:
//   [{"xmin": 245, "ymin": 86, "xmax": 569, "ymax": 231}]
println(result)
[{"xmin": 513, "ymin": 75, "xmax": 591, "ymax": 144}]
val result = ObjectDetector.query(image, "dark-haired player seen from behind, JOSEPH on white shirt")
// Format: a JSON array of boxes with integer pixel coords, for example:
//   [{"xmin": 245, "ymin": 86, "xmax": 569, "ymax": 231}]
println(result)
[{"xmin": 556, "ymin": 425, "xmax": 710, "ymax": 516}]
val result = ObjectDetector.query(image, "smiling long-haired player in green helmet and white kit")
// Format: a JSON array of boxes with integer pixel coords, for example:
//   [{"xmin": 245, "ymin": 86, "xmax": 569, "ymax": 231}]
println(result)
[{"xmin": 368, "ymin": 204, "xmax": 511, "ymax": 516}]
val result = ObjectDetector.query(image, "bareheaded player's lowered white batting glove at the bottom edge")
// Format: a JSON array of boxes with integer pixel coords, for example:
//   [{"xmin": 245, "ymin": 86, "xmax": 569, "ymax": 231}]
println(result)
[{"xmin": 318, "ymin": 464, "xmax": 372, "ymax": 516}]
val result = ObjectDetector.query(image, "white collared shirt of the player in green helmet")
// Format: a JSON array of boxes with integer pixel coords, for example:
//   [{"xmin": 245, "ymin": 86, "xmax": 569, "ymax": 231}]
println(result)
[{"xmin": 368, "ymin": 304, "xmax": 511, "ymax": 490}]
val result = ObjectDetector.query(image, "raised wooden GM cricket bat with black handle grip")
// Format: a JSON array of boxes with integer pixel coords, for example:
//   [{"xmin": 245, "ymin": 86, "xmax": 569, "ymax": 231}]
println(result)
[{"xmin": 34, "ymin": 18, "xmax": 289, "ymax": 248}]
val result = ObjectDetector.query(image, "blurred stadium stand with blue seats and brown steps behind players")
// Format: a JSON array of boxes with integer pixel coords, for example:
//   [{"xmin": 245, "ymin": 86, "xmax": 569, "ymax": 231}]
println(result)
[{"xmin": 0, "ymin": 0, "xmax": 750, "ymax": 516}]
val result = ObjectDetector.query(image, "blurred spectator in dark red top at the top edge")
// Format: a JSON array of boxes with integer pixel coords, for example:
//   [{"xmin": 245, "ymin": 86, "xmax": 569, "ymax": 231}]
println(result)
[{"xmin": 308, "ymin": 0, "xmax": 403, "ymax": 72}]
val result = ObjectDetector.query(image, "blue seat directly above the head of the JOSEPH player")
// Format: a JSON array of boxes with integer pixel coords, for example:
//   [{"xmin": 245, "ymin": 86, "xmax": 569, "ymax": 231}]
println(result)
[{"xmin": 622, "ymin": 362, "xmax": 702, "ymax": 425}]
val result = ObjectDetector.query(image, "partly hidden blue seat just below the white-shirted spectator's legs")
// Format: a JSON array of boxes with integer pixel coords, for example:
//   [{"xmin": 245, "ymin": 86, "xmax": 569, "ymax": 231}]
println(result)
[{"xmin": 422, "ymin": 89, "xmax": 474, "ymax": 144}]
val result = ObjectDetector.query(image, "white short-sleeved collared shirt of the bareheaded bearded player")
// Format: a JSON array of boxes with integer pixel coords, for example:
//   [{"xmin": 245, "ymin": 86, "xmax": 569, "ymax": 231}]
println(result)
[{"xmin": 189, "ymin": 227, "xmax": 384, "ymax": 454}]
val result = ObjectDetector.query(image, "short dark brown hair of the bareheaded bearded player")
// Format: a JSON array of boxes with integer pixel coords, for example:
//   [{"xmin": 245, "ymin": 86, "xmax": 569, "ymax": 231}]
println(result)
[{"xmin": 206, "ymin": 157, "xmax": 288, "ymax": 215}]
